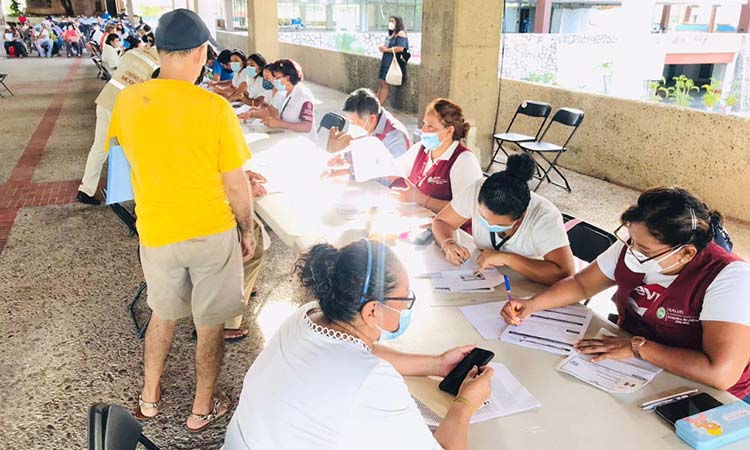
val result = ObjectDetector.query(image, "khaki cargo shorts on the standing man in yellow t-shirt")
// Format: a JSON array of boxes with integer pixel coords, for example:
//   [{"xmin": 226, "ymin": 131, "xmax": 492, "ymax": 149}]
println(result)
[{"xmin": 140, "ymin": 228, "xmax": 245, "ymax": 326}]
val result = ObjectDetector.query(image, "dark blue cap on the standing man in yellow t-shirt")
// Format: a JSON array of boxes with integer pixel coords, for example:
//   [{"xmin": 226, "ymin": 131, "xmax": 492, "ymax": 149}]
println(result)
[{"xmin": 154, "ymin": 8, "xmax": 219, "ymax": 51}]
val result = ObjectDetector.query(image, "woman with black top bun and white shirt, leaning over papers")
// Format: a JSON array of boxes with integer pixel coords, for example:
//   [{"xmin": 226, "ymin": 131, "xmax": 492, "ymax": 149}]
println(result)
[{"xmin": 432, "ymin": 153, "xmax": 575, "ymax": 284}]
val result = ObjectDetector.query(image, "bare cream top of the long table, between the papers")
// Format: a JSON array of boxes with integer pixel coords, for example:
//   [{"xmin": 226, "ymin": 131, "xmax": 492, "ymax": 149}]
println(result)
[{"xmin": 246, "ymin": 133, "xmax": 750, "ymax": 450}]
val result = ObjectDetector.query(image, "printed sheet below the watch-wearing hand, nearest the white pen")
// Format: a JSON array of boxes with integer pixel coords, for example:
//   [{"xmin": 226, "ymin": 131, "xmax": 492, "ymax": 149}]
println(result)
[{"xmin": 557, "ymin": 328, "xmax": 662, "ymax": 394}]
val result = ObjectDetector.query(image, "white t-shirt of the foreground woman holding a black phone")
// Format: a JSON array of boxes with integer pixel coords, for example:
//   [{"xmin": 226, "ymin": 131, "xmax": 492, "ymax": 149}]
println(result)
[{"xmin": 223, "ymin": 303, "xmax": 441, "ymax": 450}]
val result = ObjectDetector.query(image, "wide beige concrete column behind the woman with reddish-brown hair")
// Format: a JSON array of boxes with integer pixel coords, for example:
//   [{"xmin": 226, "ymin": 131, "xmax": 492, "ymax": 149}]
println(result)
[{"xmin": 419, "ymin": 0, "xmax": 503, "ymax": 166}]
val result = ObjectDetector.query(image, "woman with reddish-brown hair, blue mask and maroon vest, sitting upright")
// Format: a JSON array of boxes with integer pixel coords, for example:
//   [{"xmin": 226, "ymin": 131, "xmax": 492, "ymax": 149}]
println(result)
[{"xmin": 391, "ymin": 98, "xmax": 482, "ymax": 212}]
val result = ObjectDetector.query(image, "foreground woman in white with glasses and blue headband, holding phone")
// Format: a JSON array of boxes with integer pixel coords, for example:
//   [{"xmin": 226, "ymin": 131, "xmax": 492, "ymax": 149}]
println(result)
[{"xmin": 223, "ymin": 239, "xmax": 493, "ymax": 450}]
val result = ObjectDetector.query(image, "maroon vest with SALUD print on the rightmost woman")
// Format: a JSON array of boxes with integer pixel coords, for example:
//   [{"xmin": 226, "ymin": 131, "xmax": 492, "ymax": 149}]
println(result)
[{"xmin": 614, "ymin": 242, "xmax": 750, "ymax": 398}]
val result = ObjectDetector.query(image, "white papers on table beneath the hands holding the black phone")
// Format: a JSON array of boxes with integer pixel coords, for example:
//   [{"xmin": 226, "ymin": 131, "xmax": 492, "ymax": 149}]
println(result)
[{"xmin": 415, "ymin": 363, "xmax": 542, "ymax": 427}]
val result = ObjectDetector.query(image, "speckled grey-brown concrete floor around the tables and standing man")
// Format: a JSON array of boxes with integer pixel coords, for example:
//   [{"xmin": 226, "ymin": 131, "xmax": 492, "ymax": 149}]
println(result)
[{"xmin": 0, "ymin": 58, "xmax": 750, "ymax": 449}]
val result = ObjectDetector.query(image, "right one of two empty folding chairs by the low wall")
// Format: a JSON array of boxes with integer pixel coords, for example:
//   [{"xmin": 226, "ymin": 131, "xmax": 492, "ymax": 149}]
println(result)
[{"xmin": 518, "ymin": 108, "xmax": 583, "ymax": 192}]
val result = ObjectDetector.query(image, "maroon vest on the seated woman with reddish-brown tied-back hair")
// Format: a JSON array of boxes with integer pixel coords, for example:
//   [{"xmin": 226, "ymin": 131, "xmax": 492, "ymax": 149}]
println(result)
[{"xmin": 409, "ymin": 142, "xmax": 471, "ymax": 234}]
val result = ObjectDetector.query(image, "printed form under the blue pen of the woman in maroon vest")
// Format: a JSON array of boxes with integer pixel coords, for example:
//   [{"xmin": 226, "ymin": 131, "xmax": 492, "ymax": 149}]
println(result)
[{"xmin": 500, "ymin": 305, "xmax": 592, "ymax": 356}]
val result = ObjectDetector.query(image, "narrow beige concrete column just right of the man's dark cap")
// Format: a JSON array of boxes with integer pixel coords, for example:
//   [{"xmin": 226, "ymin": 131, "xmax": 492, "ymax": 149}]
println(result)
[{"xmin": 247, "ymin": 0, "xmax": 279, "ymax": 61}]
